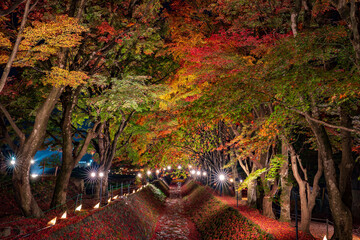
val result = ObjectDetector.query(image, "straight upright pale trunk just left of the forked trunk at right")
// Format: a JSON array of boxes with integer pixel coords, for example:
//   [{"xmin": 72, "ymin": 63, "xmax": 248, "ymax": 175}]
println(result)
[{"xmin": 280, "ymin": 141, "xmax": 292, "ymax": 222}]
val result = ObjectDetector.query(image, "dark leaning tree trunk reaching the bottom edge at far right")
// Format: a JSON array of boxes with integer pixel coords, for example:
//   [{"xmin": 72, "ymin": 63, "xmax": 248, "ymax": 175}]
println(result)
[{"xmin": 306, "ymin": 119, "xmax": 353, "ymax": 240}]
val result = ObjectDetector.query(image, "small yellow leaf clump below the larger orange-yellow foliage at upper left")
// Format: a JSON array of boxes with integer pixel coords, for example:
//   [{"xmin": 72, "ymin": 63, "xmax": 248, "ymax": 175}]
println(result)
[{"xmin": 44, "ymin": 67, "xmax": 89, "ymax": 87}]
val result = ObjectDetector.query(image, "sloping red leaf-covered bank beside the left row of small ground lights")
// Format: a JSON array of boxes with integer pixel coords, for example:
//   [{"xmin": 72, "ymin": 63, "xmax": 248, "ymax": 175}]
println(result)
[{"xmin": 30, "ymin": 184, "xmax": 166, "ymax": 239}]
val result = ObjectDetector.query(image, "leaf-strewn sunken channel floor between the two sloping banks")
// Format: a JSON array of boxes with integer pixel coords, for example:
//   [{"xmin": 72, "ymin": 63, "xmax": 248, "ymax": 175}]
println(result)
[{"xmin": 152, "ymin": 186, "xmax": 200, "ymax": 240}]
